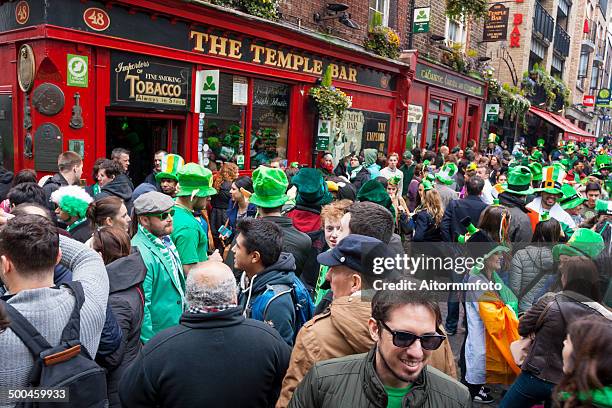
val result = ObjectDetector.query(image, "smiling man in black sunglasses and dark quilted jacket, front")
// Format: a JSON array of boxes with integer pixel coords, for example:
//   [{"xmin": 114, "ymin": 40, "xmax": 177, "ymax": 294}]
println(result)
[{"xmin": 289, "ymin": 291, "xmax": 472, "ymax": 408}]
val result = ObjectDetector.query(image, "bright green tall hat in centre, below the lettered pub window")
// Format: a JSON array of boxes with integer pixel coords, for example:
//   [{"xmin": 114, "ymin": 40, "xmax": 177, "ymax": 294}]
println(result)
[{"xmin": 249, "ymin": 166, "xmax": 289, "ymax": 208}]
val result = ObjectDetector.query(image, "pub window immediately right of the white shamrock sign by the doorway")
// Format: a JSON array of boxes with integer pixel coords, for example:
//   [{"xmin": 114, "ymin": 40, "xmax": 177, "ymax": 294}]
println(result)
[{"xmin": 202, "ymin": 73, "xmax": 247, "ymax": 171}]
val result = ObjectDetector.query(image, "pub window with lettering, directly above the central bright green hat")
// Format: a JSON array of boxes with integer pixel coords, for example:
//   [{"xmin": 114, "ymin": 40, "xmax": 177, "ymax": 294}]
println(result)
[{"xmin": 251, "ymin": 79, "xmax": 290, "ymax": 169}]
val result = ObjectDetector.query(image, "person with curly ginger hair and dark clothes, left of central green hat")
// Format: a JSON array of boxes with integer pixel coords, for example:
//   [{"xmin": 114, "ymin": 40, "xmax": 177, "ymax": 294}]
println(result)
[{"xmin": 210, "ymin": 163, "xmax": 238, "ymax": 248}]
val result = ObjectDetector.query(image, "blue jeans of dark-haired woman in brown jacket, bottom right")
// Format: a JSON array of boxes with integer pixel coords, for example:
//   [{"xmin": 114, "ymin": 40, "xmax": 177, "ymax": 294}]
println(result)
[{"xmin": 499, "ymin": 371, "xmax": 555, "ymax": 408}]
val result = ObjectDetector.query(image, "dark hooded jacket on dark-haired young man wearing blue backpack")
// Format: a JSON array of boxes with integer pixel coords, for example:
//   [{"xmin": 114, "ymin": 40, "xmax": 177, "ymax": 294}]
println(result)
[{"xmin": 238, "ymin": 252, "xmax": 295, "ymax": 346}]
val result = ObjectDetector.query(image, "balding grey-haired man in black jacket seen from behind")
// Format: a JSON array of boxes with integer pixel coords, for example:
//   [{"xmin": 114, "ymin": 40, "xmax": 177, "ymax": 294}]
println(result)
[{"xmin": 119, "ymin": 261, "xmax": 291, "ymax": 408}]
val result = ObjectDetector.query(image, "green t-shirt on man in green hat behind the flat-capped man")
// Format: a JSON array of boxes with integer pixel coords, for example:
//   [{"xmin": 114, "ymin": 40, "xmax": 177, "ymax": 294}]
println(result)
[{"xmin": 170, "ymin": 205, "xmax": 208, "ymax": 265}]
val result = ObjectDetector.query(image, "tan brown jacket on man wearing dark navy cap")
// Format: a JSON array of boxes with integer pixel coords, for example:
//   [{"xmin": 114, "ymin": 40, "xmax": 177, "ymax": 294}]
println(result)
[{"xmin": 276, "ymin": 294, "xmax": 457, "ymax": 408}]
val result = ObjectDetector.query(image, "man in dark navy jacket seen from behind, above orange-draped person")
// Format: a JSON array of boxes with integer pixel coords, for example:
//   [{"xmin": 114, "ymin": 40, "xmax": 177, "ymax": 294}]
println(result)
[{"xmin": 440, "ymin": 176, "xmax": 487, "ymax": 336}]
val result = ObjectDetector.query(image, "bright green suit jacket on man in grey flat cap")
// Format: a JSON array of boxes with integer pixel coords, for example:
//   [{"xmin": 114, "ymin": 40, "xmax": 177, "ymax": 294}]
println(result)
[{"xmin": 132, "ymin": 232, "xmax": 185, "ymax": 343}]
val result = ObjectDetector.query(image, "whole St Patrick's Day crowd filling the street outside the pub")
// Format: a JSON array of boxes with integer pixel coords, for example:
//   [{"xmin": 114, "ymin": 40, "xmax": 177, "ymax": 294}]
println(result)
[{"xmin": 0, "ymin": 134, "xmax": 612, "ymax": 408}]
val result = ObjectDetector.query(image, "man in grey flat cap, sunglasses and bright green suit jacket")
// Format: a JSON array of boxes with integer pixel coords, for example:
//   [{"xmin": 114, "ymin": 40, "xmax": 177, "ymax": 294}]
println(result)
[{"xmin": 132, "ymin": 191, "xmax": 185, "ymax": 343}]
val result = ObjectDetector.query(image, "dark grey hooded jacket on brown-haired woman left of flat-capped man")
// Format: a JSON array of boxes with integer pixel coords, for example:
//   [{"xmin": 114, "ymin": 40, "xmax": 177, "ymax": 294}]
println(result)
[{"xmin": 106, "ymin": 247, "xmax": 147, "ymax": 407}]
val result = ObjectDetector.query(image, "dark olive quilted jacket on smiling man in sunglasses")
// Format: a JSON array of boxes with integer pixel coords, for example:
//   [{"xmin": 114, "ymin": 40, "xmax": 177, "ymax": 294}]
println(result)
[{"xmin": 289, "ymin": 348, "xmax": 472, "ymax": 408}]
